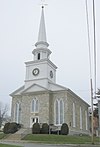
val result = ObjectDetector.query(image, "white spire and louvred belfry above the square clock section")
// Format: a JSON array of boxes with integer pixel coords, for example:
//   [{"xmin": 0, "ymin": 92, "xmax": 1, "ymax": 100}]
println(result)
[{"xmin": 32, "ymin": 6, "xmax": 51, "ymax": 60}]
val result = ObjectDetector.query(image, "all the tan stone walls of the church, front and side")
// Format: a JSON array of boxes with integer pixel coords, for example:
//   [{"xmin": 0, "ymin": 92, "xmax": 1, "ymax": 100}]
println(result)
[{"xmin": 12, "ymin": 90, "xmax": 89, "ymax": 134}]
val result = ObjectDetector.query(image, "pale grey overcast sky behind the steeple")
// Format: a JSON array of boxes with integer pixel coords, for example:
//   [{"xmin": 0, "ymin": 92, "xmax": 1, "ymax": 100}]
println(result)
[{"xmin": 0, "ymin": 0, "xmax": 100, "ymax": 113}]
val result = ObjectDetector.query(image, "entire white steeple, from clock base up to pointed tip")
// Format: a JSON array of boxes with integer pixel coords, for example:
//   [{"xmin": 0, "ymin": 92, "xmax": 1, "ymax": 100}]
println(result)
[{"xmin": 25, "ymin": 6, "xmax": 57, "ymax": 89}]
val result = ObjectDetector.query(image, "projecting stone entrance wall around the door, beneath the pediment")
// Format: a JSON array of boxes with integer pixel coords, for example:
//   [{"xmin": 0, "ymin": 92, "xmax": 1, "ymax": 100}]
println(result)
[{"xmin": 22, "ymin": 93, "xmax": 49, "ymax": 128}]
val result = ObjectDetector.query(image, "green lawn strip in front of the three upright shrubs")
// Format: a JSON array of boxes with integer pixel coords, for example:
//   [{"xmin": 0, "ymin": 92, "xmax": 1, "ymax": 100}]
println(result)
[{"xmin": 24, "ymin": 134, "xmax": 99, "ymax": 144}]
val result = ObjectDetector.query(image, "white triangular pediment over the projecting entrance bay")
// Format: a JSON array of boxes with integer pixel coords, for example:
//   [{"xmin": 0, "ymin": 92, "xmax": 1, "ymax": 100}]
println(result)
[{"xmin": 22, "ymin": 84, "xmax": 48, "ymax": 94}]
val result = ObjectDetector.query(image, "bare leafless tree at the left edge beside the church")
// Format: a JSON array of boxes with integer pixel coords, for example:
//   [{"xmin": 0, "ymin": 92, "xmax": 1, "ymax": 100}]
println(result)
[{"xmin": 0, "ymin": 102, "xmax": 9, "ymax": 128}]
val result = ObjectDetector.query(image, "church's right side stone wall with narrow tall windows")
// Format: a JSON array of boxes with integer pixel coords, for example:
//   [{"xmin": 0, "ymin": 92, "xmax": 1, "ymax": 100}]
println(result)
[{"xmin": 67, "ymin": 92, "xmax": 89, "ymax": 134}]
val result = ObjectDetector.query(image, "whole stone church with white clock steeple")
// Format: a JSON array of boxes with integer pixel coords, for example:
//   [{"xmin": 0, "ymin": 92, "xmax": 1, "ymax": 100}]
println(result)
[{"xmin": 11, "ymin": 6, "xmax": 89, "ymax": 134}]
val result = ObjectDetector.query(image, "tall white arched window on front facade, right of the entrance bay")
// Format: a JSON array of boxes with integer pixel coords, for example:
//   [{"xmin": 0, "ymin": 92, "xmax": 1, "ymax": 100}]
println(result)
[{"xmin": 55, "ymin": 99, "xmax": 64, "ymax": 125}]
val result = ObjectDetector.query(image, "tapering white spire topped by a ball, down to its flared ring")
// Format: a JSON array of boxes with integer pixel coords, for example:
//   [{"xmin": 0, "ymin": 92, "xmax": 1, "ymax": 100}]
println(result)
[{"xmin": 35, "ymin": 6, "xmax": 49, "ymax": 48}]
